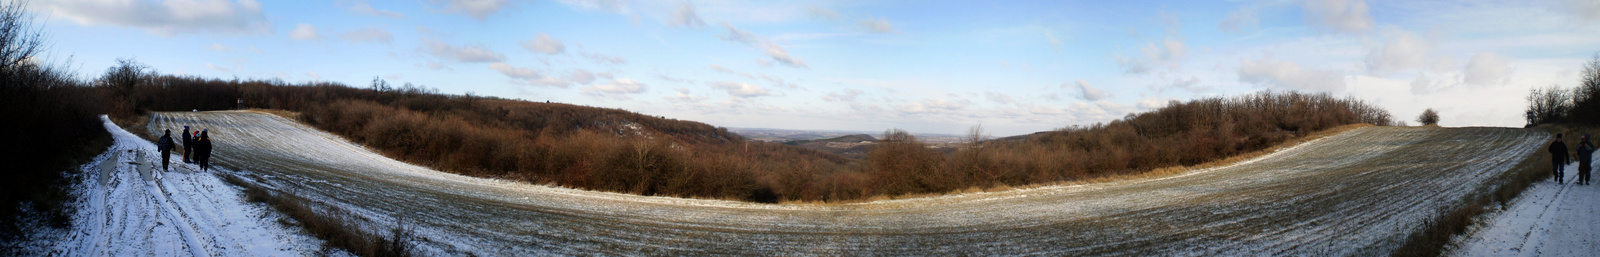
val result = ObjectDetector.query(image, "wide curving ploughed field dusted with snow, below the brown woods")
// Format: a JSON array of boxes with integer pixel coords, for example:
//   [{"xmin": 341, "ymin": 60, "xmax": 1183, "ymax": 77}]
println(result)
[{"xmin": 149, "ymin": 112, "xmax": 1547, "ymax": 255}]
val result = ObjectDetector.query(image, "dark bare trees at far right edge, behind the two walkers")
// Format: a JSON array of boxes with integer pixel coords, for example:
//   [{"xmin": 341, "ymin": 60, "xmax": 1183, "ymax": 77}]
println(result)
[{"xmin": 1523, "ymin": 54, "xmax": 1600, "ymax": 128}]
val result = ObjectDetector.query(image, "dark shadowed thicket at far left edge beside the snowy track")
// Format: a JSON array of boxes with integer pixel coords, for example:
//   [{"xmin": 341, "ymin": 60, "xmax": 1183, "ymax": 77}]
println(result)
[{"xmin": 0, "ymin": 2, "xmax": 110, "ymax": 241}]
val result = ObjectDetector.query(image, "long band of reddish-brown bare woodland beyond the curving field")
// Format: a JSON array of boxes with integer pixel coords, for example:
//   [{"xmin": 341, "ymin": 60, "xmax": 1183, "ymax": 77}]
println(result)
[{"xmin": 87, "ymin": 64, "xmax": 1390, "ymax": 203}]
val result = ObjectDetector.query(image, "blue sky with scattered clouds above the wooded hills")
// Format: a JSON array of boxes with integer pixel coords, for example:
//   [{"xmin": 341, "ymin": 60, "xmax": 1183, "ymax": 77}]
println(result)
[{"xmin": 29, "ymin": 0, "xmax": 1600, "ymax": 136}]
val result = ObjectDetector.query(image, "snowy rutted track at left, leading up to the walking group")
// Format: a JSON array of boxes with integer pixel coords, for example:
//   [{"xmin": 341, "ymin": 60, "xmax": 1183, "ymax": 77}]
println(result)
[{"xmin": 18, "ymin": 118, "xmax": 322, "ymax": 255}]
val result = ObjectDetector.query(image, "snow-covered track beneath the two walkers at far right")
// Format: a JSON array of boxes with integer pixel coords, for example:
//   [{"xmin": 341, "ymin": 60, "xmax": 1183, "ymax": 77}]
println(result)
[{"xmin": 1451, "ymin": 155, "xmax": 1600, "ymax": 255}]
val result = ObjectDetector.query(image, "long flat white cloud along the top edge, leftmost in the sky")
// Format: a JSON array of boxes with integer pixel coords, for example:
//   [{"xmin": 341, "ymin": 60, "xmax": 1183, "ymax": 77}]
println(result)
[{"xmin": 38, "ymin": 0, "xmax": 272, "ymax": 35}]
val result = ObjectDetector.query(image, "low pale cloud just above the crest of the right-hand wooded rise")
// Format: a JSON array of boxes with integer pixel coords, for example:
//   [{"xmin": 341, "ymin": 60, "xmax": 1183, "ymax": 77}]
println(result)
[{"xmin": 1238, "ymin": 56, "xmax": 1346, "ymax": 93}]
